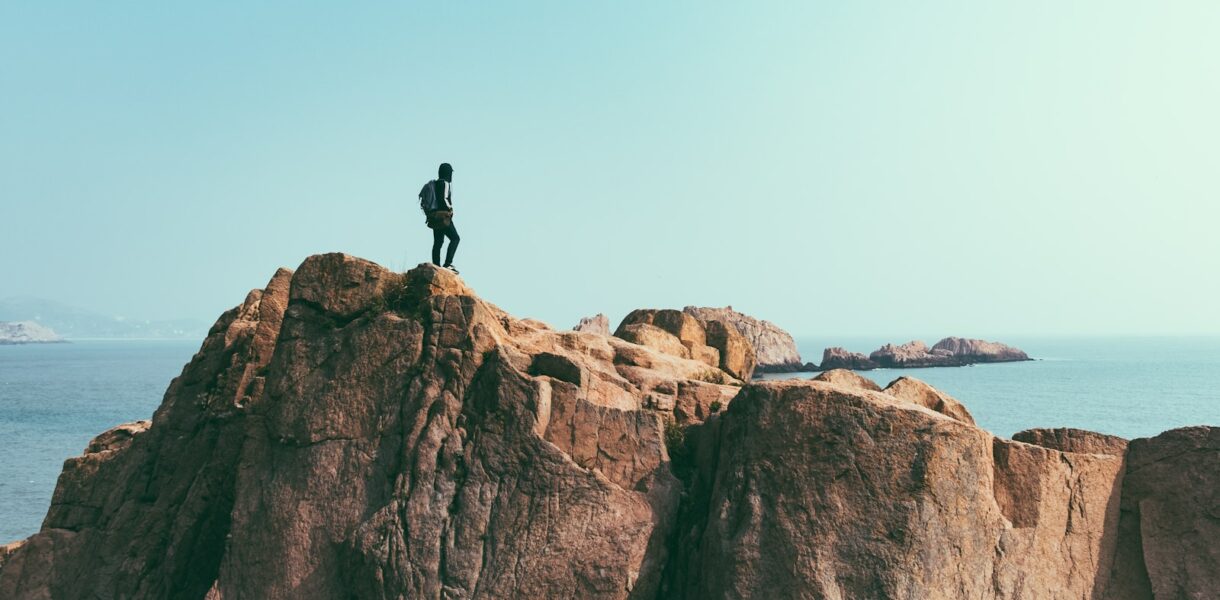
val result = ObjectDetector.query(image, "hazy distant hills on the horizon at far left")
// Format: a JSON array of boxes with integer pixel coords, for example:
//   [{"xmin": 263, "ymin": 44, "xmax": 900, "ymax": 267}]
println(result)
[{"xmin": 0, "ymin": 296, "xmax": 209, "ymax": 339}]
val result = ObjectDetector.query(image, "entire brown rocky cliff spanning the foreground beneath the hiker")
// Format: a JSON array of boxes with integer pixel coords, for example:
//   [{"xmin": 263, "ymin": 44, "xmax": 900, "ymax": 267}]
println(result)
[{"xmin": 0, "ymin": 255, "xmax": 1220, "ymax": 600}]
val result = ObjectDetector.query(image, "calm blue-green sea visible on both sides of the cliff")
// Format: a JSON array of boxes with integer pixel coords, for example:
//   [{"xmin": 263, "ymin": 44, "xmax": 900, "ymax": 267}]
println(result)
[{"xmin": 0, "ymin": 337, "xmax": 1220, "ymax": 544}]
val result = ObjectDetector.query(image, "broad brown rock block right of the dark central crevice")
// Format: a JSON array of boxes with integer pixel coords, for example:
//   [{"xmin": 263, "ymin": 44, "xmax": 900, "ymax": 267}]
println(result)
[{"xmin": 666, "ymin": 380, "xmax": 1121, "ymax": 599}]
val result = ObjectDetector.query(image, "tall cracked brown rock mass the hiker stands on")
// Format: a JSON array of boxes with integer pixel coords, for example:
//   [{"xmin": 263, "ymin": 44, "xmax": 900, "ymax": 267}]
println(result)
[{"xmin": 0, "ymin": 255, "xmax": 736, "ymax": 599}]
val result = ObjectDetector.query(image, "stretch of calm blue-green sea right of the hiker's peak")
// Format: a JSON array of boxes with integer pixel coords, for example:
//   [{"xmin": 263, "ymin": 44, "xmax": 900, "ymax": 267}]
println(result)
[{"xmin": 767, "ymin": 337, "xmax": 1220, "ymax": 439}]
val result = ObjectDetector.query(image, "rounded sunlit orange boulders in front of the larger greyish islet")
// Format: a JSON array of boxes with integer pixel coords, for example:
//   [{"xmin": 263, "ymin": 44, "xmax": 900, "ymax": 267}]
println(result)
[{"xmin": 614, "ymin": 309, "xmax": 756, "ymax": 380}]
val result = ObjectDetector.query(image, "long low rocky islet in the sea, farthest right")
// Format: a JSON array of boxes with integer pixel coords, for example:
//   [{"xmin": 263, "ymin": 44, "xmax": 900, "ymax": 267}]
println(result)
[{"xmin": 819, "ymin": 338, "xmax": 1032, "ymax": 371}]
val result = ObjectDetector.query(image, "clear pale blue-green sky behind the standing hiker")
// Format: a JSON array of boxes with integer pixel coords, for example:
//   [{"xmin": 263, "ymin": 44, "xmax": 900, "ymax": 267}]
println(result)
[{"xmin": 0, "ymin": 0, "xmax": 1220, "ymax": 334}]
